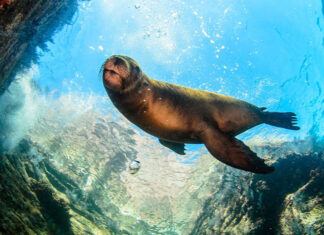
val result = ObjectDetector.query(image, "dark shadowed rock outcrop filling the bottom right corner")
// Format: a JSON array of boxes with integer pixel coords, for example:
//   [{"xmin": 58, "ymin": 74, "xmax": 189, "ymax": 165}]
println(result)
[{"xmin": 191, "ymin": 148, "xmax": 324, "ymax": 235}]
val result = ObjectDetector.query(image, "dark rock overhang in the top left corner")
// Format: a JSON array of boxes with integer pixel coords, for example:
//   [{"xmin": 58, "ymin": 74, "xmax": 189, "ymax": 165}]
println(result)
[{"xmin": 0, "ymin": 0, "xmax": 78, "ymax": 94}]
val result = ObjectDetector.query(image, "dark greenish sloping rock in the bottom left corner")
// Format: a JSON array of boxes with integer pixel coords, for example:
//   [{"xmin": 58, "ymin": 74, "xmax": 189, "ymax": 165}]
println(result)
[{"xmin": 0, "ymin": 141, "xmax": 118, "ymax": 234}]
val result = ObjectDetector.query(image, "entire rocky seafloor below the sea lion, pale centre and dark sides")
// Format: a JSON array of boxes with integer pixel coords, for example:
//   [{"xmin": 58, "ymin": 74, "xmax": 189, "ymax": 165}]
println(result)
[{"xmin": 0, "ymin": 105, "xmax": 324, "ymax": 234}]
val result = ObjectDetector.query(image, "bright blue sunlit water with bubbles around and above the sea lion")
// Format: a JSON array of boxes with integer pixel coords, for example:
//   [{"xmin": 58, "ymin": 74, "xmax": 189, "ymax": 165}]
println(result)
[{"xmin": 10, "ymin": 0, "xmax": 324, "ymax": 149}]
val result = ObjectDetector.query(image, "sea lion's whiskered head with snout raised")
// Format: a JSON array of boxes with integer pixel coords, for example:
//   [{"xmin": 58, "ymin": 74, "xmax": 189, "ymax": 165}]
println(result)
[{"xmin": 102, "ymin": 55, "xmax": 143, "ymax": 92}]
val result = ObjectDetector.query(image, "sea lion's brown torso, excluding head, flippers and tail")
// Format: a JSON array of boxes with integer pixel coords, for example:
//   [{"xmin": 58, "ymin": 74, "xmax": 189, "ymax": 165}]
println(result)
[{"xmin": 109, "ymin": 78, "xmax": 262, "ymax": 143}]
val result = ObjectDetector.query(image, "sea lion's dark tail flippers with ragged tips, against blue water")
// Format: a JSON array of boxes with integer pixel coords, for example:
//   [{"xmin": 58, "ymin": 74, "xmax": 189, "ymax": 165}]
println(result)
[{"xmin": 262, "ymin": 112, "xmax": 300, "ymax": 130}]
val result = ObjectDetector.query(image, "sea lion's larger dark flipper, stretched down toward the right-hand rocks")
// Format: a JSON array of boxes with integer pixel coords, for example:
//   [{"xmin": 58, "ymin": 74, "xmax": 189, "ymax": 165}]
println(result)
[{"xmin": 201, "ymin": 128, "xmax": 274, "ymax": 174}]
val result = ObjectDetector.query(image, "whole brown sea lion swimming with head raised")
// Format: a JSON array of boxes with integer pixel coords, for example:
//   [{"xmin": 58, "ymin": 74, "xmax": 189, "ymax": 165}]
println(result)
[{"xmin": 102, "ymin": 55, "xmax": 299, "ymax": 174}]
